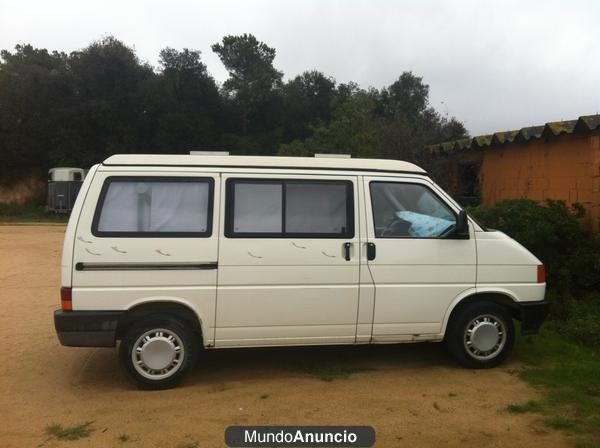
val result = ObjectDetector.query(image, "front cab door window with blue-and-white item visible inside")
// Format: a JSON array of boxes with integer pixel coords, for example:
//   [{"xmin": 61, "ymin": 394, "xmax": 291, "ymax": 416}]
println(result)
[{"xmin": 370, "ymin": 182, "xmax": 456, "ymax": 238}]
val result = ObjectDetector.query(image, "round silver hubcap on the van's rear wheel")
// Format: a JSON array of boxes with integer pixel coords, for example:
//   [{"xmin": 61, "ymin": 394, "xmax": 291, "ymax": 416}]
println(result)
[{"xmin": 131, "ymin": 328, "xmax": 185, "ymax": 380}]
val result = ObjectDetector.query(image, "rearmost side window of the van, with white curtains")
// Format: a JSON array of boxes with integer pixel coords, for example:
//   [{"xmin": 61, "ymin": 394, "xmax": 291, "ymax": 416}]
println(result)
[{"xmin": 92, "ymin": 176, "xmax": 213, "ymax": 237}]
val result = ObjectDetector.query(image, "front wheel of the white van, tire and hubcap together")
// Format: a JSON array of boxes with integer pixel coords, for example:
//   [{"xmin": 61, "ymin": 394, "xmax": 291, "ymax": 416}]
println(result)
[{"xmin": 444, "ymin": 302, "xmax": 515, "ymax": 369}]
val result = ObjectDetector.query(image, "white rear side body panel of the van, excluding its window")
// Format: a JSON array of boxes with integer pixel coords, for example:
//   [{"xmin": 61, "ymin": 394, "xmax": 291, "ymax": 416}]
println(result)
[{"xmin": 72, "ymin": 170, "xmax": 220, "ymax": 345}]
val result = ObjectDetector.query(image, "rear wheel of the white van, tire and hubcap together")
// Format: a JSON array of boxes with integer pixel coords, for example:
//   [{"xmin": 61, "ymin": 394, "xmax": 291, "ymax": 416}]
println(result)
[{"xmin": 119, "ymin": 315, "xmax": 199, "ymax": 390}]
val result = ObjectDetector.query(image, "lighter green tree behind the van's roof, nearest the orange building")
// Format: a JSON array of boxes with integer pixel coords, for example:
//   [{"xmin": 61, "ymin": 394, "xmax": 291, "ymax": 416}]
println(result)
[{"xmin": 279, "ymin": 72, "xmax": 466, "ymax": 167}]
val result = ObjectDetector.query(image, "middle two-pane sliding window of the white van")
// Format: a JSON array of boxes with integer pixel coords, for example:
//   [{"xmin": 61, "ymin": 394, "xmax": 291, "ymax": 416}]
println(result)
[{"xmin": 225, "ymin": 179, "xmax": 354, "ymax": 238}]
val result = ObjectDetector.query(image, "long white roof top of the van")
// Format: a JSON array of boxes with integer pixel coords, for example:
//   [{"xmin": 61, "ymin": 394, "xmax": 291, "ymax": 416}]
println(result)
[{"xmin": 103, "ymin": 154, "xmax": 426, "ymax": 174}]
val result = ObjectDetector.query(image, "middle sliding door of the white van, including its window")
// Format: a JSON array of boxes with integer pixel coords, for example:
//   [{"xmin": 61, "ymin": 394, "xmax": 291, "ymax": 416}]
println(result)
[{"xmin": 215, "ymin": 174, "xmax": 360, "ymax": 346}]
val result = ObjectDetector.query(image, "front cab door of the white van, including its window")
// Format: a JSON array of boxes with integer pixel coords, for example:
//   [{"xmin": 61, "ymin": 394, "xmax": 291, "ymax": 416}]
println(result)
[{"xmin": 364, "ymin": 177, "xmax": 476, "ymax": 342}]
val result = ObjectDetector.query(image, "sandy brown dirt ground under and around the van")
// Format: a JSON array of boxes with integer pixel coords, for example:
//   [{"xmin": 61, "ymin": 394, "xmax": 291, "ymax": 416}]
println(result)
[{"xmin": 0, "ymin": 226, "xmax": 570, "ymax": 448}]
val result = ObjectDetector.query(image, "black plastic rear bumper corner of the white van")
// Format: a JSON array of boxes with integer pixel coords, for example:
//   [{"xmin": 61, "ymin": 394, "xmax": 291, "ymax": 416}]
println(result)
[{"xmin": 54, "ymin": 310, "xmax": 125, "ymax": 347}]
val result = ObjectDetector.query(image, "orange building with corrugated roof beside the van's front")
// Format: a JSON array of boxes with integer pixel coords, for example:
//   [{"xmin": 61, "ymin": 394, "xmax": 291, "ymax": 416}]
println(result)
[{"xmin": 429, "ymin": 115, "xmax": 600, "ymax": 232}]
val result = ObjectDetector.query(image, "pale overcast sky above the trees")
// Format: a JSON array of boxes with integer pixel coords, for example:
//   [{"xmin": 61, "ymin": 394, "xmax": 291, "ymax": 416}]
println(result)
[{"xmin": 0, "ymin": 0, "xmax": 600, "ymax": 135}]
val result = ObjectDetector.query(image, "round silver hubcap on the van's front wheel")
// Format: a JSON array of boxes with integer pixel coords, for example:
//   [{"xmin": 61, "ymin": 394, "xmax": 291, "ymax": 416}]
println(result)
[{"xmin": 464, "ymin": 314, "xmax": 506, "ymax": 361}]
